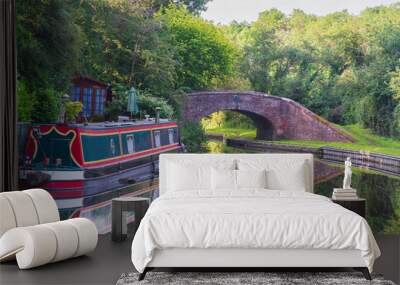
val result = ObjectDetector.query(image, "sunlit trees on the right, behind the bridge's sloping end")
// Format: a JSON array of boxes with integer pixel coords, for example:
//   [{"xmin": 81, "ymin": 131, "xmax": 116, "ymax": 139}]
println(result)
[{"xmin": 230, "ymin": 5, "xmax": 400, "ymax": 136}]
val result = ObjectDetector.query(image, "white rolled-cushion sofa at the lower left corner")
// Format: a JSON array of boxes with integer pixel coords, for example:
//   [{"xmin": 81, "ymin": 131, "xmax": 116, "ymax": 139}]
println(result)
[{"xmin": 0, "ymin": 189, "xmax": 98, "ymax": 269}]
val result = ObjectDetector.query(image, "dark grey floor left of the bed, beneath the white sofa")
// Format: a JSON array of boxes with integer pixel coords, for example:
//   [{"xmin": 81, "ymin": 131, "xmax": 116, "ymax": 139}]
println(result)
[{"xmin": 0, "ymin": 235, "xmax": 135, "ymax": 285}]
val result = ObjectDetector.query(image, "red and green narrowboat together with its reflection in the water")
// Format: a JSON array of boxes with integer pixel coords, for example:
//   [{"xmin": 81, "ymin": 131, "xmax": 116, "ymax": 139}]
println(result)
[{"xmin": 20, "ymin": 119, "xmax": 181, "ymax": 231}]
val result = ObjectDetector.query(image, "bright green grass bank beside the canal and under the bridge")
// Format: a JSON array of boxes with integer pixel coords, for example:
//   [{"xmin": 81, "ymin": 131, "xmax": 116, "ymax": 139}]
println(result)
[{"xmin": 206, "ymin": 125, "xmax": 400, "ymax": 156}]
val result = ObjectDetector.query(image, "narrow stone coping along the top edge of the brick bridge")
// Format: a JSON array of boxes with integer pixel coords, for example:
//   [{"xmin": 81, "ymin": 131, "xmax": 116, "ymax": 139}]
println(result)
[{"xmin": 187, "ymin": 90, "xmax": 355, "ymax": 142}]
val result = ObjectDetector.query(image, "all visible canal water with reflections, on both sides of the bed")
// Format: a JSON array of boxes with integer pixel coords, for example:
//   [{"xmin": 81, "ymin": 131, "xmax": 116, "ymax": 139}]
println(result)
[{"xmin": 80, "ymin": 141, "xmax": 400, "ymax": 234}]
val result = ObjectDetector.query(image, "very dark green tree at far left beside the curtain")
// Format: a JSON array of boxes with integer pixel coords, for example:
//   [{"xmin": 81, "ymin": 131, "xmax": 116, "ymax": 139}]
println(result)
[{"xmin": 16, "ymin": 0, "xmax": 80, "ymax": 122}]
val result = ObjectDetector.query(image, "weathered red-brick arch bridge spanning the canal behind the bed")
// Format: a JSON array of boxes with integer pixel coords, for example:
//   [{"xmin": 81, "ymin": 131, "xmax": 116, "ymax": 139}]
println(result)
[{"xmin": 183, "ymin": 91, "xmax": 354, "ymax": 142}]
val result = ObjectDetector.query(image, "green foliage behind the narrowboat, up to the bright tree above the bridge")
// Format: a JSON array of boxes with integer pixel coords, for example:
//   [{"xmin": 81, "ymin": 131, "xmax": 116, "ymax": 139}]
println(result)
[{"xmin": 17, "ymin": 0, "xmax": 230, "ymax": 127}]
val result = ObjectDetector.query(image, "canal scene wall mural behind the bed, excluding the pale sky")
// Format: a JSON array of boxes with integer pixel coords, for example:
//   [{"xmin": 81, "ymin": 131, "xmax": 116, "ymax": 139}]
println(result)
[{"xmin": 16, "ymin": 0, "xmax": 400, "ymax": 233}]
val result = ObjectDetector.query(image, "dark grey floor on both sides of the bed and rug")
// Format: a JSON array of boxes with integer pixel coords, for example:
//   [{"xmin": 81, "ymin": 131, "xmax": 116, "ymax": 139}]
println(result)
[{"xmin": 0, "ymin": 235, "xmax": 400, "ymax": 285}]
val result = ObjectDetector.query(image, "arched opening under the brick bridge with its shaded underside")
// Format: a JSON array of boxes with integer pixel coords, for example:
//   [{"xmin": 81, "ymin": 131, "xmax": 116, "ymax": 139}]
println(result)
[{"xmin": 201, "ymin": 109, "xmax": 275, "ymax": 140}]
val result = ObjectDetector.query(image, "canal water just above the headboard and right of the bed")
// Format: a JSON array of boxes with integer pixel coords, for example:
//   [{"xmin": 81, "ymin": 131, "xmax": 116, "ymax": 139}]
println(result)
[{"xmin": 208, "ymin": 141, "xmax": 400, "ymax": 234}]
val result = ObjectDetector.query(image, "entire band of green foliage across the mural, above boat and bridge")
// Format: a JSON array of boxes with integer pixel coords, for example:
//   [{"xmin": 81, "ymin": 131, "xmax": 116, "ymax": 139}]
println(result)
[{"xmin": 17, "ymin": 0, "xmax": 400, "ymax": 141}]
